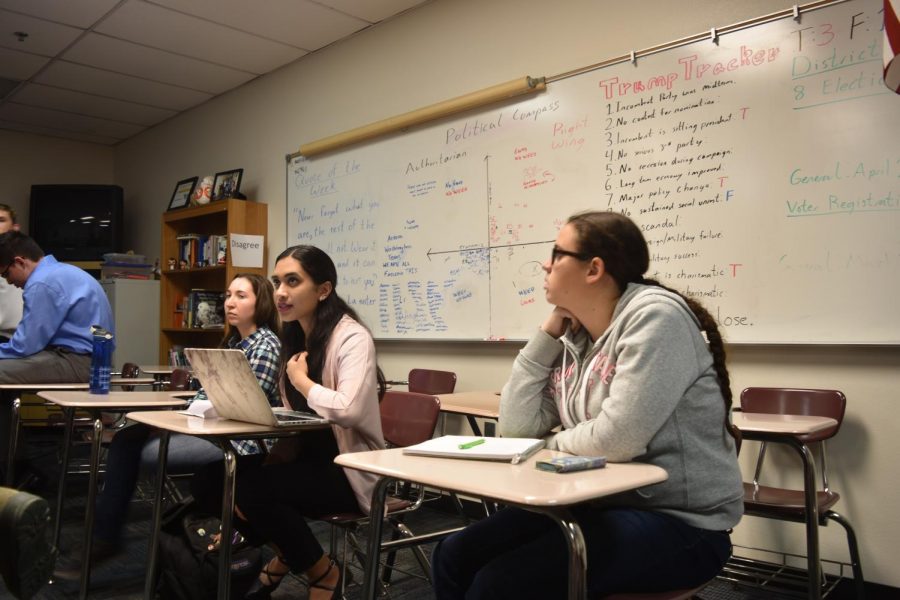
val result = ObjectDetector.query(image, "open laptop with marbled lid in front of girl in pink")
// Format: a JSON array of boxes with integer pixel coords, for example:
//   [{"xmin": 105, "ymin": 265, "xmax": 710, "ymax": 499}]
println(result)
[{"xmin": 184, "ymin": 348, "xmax": 328, "ymax": 427}]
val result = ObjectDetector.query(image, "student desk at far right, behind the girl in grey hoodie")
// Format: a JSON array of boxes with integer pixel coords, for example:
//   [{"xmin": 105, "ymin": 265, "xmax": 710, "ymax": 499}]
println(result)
[{"xmin": 732, "ymin": 411, "xmax": 837, "ymax": 600}]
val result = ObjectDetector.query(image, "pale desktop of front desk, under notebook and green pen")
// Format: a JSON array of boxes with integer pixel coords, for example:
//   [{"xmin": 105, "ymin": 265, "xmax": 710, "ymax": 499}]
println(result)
[{"xmin": 335, "ymin": 448, "xmax": 668, "ymax": 506}]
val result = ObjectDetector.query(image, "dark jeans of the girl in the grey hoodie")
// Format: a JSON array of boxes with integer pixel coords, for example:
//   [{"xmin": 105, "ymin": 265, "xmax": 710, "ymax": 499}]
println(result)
[{"xmin": 431, "ymin": 506, "xmax": 731, "ymax": 600}]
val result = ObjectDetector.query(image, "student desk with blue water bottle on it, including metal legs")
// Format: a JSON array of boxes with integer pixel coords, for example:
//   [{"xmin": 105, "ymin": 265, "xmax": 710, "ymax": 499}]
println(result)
[{"xmin": 38, "ymin": 386, "xmax": 184, "ymax": 598}]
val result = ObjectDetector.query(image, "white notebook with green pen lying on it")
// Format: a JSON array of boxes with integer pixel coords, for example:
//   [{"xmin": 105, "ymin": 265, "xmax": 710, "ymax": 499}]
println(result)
[{"xmin": 403, "ymin": 435, "xmax": 544, "ymax": 465}]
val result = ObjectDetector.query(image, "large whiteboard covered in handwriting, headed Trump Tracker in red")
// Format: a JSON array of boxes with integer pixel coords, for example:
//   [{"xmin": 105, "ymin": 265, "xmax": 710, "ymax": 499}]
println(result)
[{"xmin": 287, "ymin": 0, "xmax": 900, "ymax": 344}]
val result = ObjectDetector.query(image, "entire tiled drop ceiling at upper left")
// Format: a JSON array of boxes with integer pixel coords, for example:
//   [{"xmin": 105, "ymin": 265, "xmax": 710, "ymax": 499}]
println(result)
[{"xmin": 0, "ymin": 0, "xmax": 428, "ymax": 145}]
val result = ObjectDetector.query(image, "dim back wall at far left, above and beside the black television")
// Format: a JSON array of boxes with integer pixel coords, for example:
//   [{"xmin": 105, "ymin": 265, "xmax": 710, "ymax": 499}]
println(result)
[{"xmin": 0, "ymin": 129, "xmax": 116, "ymax": 231}]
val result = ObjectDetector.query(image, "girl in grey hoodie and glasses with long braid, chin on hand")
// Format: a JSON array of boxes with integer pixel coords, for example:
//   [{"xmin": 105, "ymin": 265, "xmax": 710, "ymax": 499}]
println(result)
[{"xmin": 432, "ymin": 212, "xmax": 743, "ymax": 600}]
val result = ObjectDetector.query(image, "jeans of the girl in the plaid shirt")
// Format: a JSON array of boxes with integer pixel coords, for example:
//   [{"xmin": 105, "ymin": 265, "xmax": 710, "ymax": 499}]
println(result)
[{"xmin": 94, "ymin": 423, "xmax": 222, "ymax": 545}]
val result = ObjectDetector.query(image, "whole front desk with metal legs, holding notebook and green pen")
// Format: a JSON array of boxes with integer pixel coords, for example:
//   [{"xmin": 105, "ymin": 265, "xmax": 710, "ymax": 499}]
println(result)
[{"xmin": 334, "ymin": 448, "xmax": 668, "ymax": 600}]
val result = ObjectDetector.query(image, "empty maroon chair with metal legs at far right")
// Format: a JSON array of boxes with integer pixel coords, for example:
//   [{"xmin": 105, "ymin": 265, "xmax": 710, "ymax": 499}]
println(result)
[{"xmin": 741, "ymin": 387, "xmax": 864, "ymax": 598}]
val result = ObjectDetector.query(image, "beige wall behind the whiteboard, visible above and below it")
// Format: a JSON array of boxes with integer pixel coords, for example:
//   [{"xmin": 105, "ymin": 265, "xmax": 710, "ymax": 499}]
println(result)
[{"xmin": 115, "ymin": 0, "xmax": 900, "ymax": 587}]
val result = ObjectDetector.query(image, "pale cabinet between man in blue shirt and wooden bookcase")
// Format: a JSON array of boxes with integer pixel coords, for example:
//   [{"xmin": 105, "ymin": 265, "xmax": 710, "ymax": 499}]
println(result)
[{"xmin": 100, "ymin": 279, "xmax": 159, "ymax": 370}]
